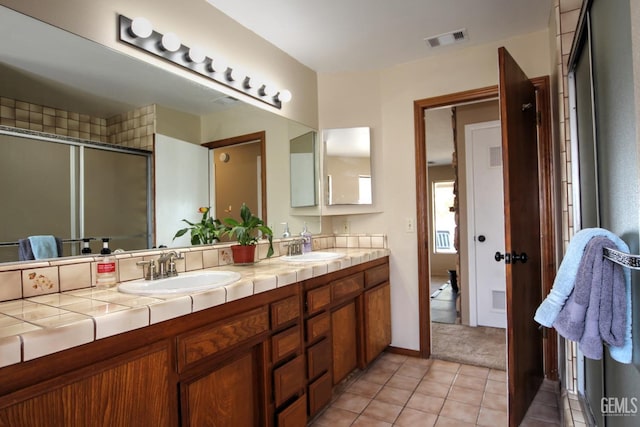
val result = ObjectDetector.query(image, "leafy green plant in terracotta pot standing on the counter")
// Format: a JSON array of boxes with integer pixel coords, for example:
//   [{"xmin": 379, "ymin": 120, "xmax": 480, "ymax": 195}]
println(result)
[{"xmin": 222, "ymin": 203, "xmax": 273, "ymax": 264}]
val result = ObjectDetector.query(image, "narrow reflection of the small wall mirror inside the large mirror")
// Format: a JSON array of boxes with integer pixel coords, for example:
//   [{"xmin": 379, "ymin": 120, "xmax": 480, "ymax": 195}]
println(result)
[{"xmin": 289, "ymin": 131, "xmax": 318, "ymax": 208}]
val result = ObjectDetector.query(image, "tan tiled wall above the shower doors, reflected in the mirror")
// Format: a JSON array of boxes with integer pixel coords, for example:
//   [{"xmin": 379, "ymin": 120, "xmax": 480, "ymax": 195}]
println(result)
[{"xmin": 0, "ymin": 97, "xmax": 156, "ymax": 151}]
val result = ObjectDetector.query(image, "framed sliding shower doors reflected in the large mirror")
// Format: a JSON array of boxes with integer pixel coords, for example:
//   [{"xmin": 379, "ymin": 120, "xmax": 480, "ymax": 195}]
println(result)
[{"xmin": 0, "ymin": 130, "xmax": 151, "ymax": 262}]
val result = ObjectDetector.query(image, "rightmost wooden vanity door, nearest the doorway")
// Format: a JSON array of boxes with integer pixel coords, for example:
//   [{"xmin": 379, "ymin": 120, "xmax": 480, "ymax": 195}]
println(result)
[{"xmin": 364, "ymin": 282, "xmax": 391, "ymax": 364}]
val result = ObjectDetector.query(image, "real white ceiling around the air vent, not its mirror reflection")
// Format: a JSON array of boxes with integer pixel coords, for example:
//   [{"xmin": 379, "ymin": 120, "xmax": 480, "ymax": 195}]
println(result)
[{"xmin": 206, "ymin": 0, "xmax": 552, "ymax": 72}]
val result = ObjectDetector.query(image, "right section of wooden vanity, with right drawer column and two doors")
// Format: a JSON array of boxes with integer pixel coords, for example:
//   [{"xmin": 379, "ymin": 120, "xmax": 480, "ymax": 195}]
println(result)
[{"xmin": 302, "ymin": 257, "xmax": 391, "ymax": 417}]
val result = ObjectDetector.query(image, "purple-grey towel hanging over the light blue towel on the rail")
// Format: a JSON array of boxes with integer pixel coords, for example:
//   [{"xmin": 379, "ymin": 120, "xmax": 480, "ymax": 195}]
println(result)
[{"xmin": 553, "ymin": 236, "xmax": 627, "ymax": 360}]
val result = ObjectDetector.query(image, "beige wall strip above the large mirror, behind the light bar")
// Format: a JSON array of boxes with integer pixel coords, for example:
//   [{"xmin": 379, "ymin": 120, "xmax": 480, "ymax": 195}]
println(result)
[{"xmin": 0, "ymin": 0, "xmax": 318, "ymax": 128}]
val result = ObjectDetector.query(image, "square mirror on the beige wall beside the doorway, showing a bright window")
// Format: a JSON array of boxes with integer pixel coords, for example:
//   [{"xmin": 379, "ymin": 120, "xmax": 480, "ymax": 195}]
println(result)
[{"xmin": 322, "ymin": 127, "xmax": 372, "ymax": 205}]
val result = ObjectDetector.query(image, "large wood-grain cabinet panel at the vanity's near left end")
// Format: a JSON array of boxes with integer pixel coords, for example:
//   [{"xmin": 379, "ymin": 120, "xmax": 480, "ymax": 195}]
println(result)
[{"xmin": 0, "ymin": 345, "xmax": 177, "ymax": 427}]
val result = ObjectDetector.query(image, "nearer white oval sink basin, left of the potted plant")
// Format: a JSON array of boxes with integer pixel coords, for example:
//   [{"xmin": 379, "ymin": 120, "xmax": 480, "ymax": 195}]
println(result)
[{"xmin": 118, "ymin": 270, "xmax": 240, "ymax": 295}]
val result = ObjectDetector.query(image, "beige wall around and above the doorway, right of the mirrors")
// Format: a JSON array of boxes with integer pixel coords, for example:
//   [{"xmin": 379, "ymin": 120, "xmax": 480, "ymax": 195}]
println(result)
[{"xmin": 318, "ymin": 31, "xmax": 551, "ymax": 350}]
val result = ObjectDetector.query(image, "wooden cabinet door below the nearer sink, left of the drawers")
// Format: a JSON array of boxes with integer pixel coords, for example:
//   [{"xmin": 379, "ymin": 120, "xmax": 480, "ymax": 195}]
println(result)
[{"xmin": 181, "ymin": 349, "xmax": 259, "ymax": 427}]
